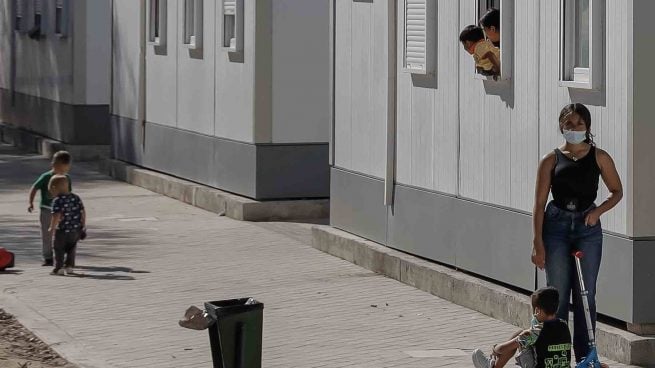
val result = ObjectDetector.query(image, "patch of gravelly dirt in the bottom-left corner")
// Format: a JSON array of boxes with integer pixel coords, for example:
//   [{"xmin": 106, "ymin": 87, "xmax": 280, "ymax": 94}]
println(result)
[{"xmin": 0, "ymin": 309, "xmax": 76, "ymax": 368}]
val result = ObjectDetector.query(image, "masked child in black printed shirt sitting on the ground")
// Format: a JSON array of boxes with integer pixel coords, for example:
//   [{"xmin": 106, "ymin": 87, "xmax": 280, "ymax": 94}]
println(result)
[{"xmin": 473, "ymin": 287, "xmax": 571, "ymax": 368}]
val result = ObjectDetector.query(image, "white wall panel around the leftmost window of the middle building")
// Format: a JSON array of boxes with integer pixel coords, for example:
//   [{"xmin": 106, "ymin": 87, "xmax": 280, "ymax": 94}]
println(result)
[{"xmin": 146, "ymin": 0, "xmax": 180, "ymax": 127}]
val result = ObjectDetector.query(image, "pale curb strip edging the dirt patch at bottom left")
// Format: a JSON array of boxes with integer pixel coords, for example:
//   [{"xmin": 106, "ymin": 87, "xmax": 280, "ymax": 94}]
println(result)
[{"xmin": 0, "ymin": 293, "xmax": 115, "ymax": 368}]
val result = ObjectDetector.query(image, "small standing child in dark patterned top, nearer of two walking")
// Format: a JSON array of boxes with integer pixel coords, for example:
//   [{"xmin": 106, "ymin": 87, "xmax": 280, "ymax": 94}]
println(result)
[{"xmin": 48, "ymin": 175, "xmax": 86, "ymax": 275}]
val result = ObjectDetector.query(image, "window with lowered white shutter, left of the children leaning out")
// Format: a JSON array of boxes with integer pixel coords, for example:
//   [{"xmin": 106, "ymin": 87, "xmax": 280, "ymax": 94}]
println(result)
[{"xmin": 402, "ymin": 0, "xmax": 437, "ymax": 74}]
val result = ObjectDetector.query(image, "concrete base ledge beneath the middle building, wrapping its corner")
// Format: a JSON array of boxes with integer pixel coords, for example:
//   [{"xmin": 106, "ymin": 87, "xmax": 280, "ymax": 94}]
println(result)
[{"xmin": 99, "ymin": 160, "xmax": 330, "ymax": 221}]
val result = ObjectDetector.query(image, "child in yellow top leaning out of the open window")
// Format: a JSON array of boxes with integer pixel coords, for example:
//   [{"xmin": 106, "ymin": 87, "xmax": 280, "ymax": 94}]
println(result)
[{"xmin": 459, "ymin": 25, "xmax": 500, "ymax": 77}]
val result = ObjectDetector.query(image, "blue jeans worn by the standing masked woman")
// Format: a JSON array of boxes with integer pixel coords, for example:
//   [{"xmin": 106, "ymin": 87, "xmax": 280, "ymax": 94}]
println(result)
[{"xmin": 543, "ymin": 202, "xmax": 603, "ymax": 361}]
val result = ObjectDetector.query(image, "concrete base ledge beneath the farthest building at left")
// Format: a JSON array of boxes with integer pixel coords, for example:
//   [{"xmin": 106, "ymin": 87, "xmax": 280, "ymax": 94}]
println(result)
[{"xmin": 0, "ymin": 123, "xmax": 110, "ymax": 161}]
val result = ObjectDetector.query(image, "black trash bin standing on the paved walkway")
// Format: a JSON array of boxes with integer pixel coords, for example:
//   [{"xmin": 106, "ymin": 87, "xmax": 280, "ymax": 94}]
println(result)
[{"xmin": 205, "ymin": 298, "xmax": 264, "ymax": 368}]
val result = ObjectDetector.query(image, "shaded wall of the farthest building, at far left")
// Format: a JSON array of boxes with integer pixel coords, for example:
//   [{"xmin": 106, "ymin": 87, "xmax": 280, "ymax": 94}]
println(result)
[{"xmin": 0, "ymin": 0, "xmax": 111, "ymax": 144}]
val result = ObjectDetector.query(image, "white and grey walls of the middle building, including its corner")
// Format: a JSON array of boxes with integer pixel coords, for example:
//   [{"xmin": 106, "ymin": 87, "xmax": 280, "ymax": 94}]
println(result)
[{"xmin": 112, "ymin": 0, "xmax": 330, "ymax": 199}]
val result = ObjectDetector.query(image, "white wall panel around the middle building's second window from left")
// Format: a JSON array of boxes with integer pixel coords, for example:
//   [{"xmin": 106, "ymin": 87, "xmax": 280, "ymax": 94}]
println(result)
[{"xmin": 177, "ymin": 0, "xmax": 216, "ymax": 135}]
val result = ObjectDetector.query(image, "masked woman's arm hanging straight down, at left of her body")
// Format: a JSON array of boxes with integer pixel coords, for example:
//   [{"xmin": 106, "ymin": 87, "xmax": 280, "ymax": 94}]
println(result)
[{"xmin": 532, "ymin": 152, "xmax": 555, "ymax": 269}]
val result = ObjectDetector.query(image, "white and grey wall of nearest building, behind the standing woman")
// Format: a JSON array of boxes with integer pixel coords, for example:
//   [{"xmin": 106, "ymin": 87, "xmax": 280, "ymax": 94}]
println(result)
[{"xmin": 331, "ymin": 0, "xmax": 655, "ymax": 323}]
